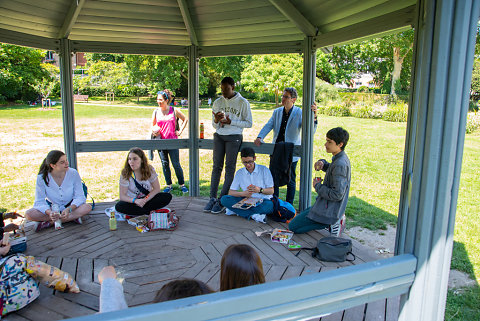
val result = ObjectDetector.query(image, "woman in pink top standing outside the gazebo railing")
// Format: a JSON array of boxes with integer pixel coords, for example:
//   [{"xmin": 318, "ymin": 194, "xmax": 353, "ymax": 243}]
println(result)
[{"xmin": 152, "ymin": 90, "xmax": 188, "ymax": 193}]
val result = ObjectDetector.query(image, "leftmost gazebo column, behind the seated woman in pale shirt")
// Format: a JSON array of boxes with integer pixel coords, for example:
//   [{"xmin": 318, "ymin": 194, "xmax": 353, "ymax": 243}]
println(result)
[{"xmin": 59, "ymin": 38, "xmax": 77, "ymax": 168}]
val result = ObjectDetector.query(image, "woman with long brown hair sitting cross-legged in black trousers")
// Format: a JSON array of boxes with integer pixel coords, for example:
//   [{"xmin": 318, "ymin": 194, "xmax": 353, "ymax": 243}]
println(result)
[{"xmin": 115, "ymin": 147, "xmax": 172, "ymax": 216}]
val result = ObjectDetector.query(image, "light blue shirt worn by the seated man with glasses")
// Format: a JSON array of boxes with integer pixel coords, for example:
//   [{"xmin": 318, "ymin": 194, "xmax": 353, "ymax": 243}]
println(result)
[{"xmin": 230, "ymin": 163, "xmax": 273, "ymax": 199}]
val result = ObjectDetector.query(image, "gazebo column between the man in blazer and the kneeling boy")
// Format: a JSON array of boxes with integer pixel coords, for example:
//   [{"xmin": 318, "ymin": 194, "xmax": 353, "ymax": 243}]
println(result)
[{"xmin": 298, "ymin": 37, "xmax": 316, "ymax": 211}]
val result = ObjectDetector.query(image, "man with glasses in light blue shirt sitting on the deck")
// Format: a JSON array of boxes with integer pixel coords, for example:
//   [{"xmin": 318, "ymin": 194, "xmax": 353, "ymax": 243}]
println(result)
[{"xmin": 221, "ymin": 147, "xmax": 273, "ymax": 223}]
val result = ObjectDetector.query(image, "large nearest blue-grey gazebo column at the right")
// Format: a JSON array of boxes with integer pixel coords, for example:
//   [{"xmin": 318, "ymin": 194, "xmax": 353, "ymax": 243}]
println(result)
[{"xmin": 396, "ymin": 0, "xmax": 480, "ymax": 321}]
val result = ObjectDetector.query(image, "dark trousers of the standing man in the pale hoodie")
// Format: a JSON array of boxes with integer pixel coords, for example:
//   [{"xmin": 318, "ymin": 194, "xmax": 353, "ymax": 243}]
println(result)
[{"xmin": 210, "ymin": 133, "xmax": 242, "ymax": 198}]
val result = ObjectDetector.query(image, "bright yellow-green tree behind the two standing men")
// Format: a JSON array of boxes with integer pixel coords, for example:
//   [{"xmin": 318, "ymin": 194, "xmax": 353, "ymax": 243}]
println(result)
[{"xmin": 242, "ymin": 54, "xmax": 303, "ymax": 106}]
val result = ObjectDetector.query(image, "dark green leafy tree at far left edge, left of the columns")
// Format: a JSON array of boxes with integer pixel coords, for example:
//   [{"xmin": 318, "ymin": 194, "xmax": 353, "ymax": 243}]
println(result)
[{"xmin": 0, "ymin": 44, "xmax": 48, "ymax": 101}]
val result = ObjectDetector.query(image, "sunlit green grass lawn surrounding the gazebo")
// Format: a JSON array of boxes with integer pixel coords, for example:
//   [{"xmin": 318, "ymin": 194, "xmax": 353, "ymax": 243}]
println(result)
[{"xmin": 0, "ymin": 103, "xmax": 480, "ymax": 320}]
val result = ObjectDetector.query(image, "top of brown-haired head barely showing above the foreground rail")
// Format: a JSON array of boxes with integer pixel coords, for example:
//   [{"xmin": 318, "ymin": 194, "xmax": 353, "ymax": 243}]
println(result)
[{"xmin": 153, "ymin": 279, "xmax": 214, "ymax": 303}]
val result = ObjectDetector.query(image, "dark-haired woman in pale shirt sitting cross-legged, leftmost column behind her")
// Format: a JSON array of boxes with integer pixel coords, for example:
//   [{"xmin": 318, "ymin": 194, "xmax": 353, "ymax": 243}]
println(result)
[{"xmin": 25, "ymin": 150, "xmax": 92, "ymax": 232}]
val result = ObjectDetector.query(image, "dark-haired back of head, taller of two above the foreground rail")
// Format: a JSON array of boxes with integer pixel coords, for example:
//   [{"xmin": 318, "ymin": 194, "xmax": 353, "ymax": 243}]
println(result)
[{"xmin": 220, "ymin": 244, "xmax": 265, "ymax": 291}]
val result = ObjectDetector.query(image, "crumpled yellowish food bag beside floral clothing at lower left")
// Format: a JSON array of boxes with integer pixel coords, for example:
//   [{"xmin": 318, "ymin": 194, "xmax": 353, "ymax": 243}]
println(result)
[{"xmin": 26, "ymin": 256, "xmax": 80, "ymax": 293}]
